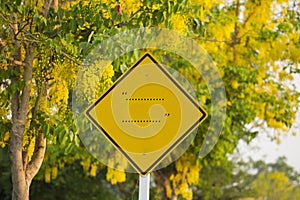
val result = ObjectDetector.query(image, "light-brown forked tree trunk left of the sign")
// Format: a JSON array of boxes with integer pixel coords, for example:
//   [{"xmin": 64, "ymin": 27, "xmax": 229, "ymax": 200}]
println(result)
[{"xmin": 9, "ymin": 13, "xmax": 46, "ymax": 200}]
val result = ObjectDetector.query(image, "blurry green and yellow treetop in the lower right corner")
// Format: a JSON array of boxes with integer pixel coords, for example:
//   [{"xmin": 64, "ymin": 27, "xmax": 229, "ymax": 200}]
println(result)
[{"xmin": 195, "ymin": 157, "xmax": 300, "ymax": 200}]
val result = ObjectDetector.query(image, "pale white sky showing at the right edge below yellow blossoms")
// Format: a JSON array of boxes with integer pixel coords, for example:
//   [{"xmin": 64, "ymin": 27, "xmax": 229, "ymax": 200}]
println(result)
[{"xmin": 237, "ymin": 75, "xmax": 300, "ymax": 172}]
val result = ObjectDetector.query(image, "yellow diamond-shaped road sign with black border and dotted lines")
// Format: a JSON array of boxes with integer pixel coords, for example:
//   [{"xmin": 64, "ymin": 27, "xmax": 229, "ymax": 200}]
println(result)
[{"xmin": 85, "ymin": 53, "xmax": 207, "ymax": 175}]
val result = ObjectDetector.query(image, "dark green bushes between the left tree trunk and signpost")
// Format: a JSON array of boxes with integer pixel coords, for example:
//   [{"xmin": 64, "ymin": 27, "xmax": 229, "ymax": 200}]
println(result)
[{"xmin": 30, "ymin": 162, "xmax": 123, "ymax": 200}]
